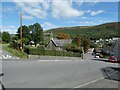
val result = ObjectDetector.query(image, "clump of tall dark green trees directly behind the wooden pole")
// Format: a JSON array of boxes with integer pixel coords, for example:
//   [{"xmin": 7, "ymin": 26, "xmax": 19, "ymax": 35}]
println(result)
[{"xmin": 16, "ymin": 23, "xmax": 43, "ymax": 46}]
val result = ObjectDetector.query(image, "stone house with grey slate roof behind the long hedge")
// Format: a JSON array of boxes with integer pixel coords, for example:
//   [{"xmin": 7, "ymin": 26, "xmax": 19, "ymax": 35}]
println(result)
[{"xmin": 46, "ymin": 38, "xmax": 72, "ymax": 50}]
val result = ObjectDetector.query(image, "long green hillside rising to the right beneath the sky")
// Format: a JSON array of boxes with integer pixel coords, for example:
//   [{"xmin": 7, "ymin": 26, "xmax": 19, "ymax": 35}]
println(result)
[{"xmin": 47, "ymin": 22, "xmax": 118, "ymax": 39}]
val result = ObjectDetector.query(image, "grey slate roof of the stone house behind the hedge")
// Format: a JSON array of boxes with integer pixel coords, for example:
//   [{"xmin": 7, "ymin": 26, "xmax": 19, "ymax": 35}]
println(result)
[{"xmin": 51, "ymin": 39, "xmax": 72, "ymax": 47}]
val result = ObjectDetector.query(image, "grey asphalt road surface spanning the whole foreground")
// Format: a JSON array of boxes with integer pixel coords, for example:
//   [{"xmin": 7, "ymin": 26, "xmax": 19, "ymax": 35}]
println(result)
[{"xmin": 2, "ymin": 44, "xmax": 120, "ymax": 89}]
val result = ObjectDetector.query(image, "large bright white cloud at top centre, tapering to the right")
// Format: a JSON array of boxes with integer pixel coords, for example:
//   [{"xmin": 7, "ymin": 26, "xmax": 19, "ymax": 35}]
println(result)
[{"xmin": 52, "ymin": 0, "xmax": 84, "ymax": 18}]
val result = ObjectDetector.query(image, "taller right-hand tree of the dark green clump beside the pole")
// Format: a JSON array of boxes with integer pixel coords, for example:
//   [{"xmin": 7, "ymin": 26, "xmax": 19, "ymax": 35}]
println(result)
[{"xmin": 29, "ymin": 23, "xmax": 44, "ymax": 46}]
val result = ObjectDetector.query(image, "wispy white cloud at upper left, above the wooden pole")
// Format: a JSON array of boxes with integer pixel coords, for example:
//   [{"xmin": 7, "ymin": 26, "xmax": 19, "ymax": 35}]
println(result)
[{"xmin": 15, "ymin": 0, "xmax": 50, "ymax": 19}]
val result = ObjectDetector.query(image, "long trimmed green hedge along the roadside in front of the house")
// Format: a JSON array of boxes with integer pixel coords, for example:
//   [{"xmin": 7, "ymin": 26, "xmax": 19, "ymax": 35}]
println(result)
[{"xmin": 24, "ymin": 47, "xmax": 81, "ymax": 57}]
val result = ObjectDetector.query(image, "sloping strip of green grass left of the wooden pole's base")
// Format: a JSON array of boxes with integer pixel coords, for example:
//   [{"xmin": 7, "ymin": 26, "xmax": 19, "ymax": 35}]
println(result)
[{"xmin": 2, "ymin": 44, "xmax": 28, "ymax": 59}]
